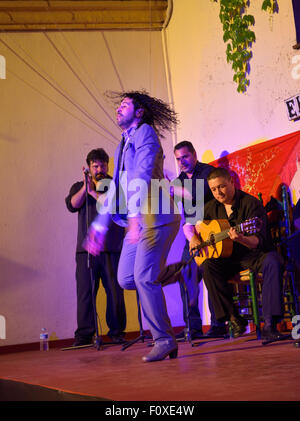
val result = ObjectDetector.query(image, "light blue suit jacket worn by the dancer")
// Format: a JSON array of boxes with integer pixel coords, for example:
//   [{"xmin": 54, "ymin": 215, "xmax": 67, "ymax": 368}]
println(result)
[{"xmin": 97, "ymin": 124, "xmax": 181, "ymax": 227}]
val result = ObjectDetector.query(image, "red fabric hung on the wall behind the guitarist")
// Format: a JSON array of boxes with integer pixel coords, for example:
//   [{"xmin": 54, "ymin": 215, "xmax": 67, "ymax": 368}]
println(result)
[{"xmin": 210, "ymin": 130, "xmax": 300, "ymax": 204}]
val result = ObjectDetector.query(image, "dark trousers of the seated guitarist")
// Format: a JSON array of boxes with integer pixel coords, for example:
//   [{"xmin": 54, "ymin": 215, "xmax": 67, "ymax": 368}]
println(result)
[{"xmin": 202, "ymin": 252, "xmax": 283, "ymax": 321}]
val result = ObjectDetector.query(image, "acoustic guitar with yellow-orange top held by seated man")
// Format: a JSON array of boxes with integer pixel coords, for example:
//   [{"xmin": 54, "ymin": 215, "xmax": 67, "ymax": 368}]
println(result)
[{"xmin": 192, "ymin": 217, "xmax": 262, "ymax": 266}]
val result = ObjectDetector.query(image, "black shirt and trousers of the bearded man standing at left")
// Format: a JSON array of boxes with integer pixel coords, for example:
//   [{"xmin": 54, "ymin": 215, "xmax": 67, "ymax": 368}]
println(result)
[{"xmin": 65, "ymin": 177, "xmax": 126, "ymax": 341}]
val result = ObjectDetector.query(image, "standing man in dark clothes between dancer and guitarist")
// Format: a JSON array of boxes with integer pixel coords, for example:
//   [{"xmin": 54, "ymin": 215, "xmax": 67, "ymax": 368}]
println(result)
[{"xmin": 174, "ymin": 140, "xmax": 226, "ymax": 339}]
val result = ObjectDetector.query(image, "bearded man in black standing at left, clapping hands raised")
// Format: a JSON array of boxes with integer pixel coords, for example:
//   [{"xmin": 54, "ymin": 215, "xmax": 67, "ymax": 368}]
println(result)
[{"xmin": 66, "ymin": 148, "xmax": 126, "ymax": 346}]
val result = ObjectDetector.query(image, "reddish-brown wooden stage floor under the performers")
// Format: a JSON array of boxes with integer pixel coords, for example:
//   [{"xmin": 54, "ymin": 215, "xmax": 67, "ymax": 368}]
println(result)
[{"xmin": 0, "ymin": 334, "xmax": 300, "ymax": 402}]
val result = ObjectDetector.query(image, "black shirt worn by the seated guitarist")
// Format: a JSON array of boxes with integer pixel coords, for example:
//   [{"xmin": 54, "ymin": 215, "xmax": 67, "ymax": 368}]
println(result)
[{"xmin": 204, "ymin": 189, "xmax": 274, "ymax": 267}]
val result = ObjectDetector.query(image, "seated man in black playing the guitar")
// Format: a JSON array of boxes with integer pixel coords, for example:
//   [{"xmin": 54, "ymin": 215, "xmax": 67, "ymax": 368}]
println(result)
[{"xmin": 190, "ymin": 168, "xmax": 283, "ymax": 341}]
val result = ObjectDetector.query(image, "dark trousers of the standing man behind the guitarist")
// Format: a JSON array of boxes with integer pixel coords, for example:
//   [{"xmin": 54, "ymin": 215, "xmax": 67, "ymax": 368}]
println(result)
[{"xmin": 179, "ymin": 242, "xmax": 223, "ymax": 331}]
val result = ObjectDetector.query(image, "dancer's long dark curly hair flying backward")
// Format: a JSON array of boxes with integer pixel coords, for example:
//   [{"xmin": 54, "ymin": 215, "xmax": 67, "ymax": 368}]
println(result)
[{"xmin": 106, "ymin": 90, "xmax": 179, "ymax": 138}]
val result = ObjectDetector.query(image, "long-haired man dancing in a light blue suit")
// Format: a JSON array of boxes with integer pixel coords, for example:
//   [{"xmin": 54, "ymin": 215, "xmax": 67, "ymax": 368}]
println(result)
[{"xmin": 85, "ymin": 91, "xmax": 181, "ymax": 362}]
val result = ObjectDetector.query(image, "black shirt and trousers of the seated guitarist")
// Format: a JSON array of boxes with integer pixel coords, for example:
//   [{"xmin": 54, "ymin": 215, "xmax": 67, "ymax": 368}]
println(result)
[{"xmin": 202, "ymin": 190, "xmax": 282, "ymax": 321}]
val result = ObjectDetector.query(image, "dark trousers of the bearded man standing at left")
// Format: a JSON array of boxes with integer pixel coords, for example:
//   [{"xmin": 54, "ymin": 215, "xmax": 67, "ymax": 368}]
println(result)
[{"xmin": 75, "ymin": 252, "xmax": 126, "ymax": 339}]
